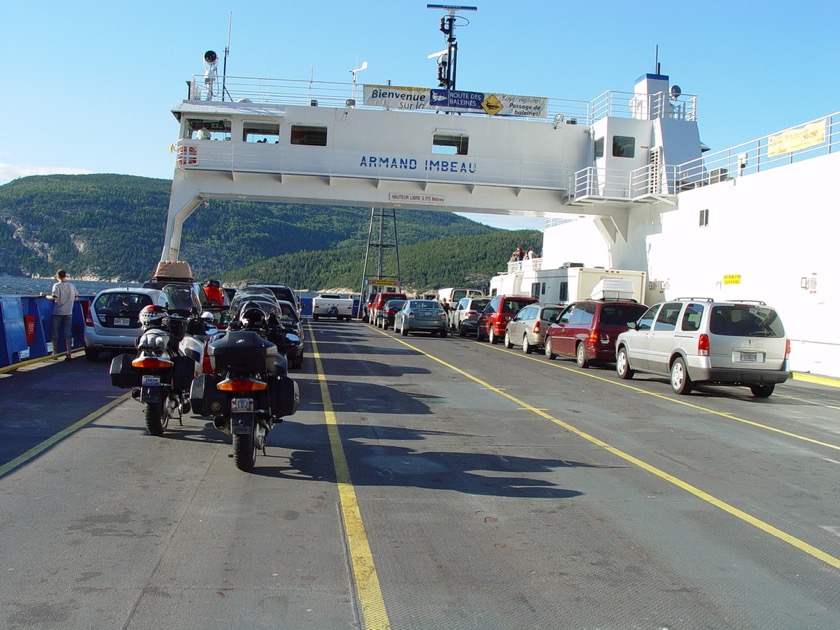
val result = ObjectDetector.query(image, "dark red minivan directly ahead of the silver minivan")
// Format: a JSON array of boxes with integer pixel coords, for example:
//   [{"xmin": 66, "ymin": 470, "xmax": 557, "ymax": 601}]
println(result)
[{"xmin": 545, "ymin": 300, "xmax": 647, "ymax": 368}]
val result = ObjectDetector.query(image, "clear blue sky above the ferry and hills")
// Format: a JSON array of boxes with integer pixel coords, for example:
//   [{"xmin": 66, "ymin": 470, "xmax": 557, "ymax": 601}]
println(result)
[{"xmin": 0, "ymin": 0, "xmax": 840, "ymax": 227}]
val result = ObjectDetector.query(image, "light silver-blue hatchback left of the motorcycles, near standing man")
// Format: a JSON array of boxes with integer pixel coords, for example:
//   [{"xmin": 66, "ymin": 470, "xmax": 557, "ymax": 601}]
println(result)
[{"xmin": 85, "ymin": 288, "xmax": 171, "ymax": 361}]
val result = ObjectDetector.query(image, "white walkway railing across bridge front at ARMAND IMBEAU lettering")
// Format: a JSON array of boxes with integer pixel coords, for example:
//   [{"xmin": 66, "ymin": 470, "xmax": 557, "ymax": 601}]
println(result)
[{"xmin": 173, "ymin": 140, "xmax": 571, "ymax": 192}]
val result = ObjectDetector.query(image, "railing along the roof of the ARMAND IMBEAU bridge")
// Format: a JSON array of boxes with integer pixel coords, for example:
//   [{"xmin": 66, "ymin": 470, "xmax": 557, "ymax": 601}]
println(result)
[{"xmin": 187, "ymin": 75, "xmax": 697, "ymax": 125}]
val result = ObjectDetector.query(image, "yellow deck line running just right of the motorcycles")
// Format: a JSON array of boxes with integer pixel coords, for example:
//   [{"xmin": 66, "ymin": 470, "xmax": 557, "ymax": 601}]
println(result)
[{"xmin": 309, "ymin": 327, "xmax": 390, "ymax": 630}]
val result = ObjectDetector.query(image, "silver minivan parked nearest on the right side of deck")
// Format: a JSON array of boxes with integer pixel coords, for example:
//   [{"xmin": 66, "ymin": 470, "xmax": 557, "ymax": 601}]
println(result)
[{"xmin": 616, "ymin": 298, "xmax": 790, "ymax": 398}]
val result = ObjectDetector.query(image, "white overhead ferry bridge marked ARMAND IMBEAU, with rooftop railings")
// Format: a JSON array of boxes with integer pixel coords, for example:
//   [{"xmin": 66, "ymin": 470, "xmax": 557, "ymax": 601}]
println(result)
[{"xmin": 161, "ymin": 74, "xmax": 707, "ymax": 260}]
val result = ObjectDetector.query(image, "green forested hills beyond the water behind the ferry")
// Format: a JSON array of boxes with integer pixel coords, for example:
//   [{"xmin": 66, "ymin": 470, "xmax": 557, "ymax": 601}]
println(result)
[{"xmin": 0, "ymin": 174, "xmax": 541, "ymax": 289}]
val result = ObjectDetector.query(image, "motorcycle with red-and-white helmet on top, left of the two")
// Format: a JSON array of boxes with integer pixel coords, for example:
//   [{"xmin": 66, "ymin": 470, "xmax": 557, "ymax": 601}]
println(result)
[{"xmin": 111, "ymin": 305, "xmax": 205, "ymax": 436}]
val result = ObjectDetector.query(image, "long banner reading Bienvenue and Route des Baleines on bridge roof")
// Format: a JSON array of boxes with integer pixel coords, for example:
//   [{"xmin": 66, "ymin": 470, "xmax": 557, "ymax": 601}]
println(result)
[{"xmin": 364, "ymin": 85, "xmax": 548, "ymax": 118}]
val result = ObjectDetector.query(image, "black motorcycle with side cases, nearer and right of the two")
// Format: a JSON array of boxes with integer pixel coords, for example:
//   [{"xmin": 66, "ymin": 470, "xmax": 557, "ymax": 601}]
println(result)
[{"xmin": 190, "ymin": 305, "xmax": 300, "ymax": 471}]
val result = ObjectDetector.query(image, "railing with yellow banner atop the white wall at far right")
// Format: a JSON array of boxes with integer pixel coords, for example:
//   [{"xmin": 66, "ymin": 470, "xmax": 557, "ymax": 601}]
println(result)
[{"xmin": 677, "ymin": 112, "xmax": 840, "ymax": 190}]
